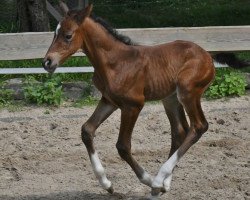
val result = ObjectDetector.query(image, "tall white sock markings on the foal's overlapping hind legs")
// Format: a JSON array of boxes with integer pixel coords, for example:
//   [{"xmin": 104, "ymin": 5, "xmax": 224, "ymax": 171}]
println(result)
[{"xmin": 152, "ymin": 150, "xmax": 180, "ymax": 188}]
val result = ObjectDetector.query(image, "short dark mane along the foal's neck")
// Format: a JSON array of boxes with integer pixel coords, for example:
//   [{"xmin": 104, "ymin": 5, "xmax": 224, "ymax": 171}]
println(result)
[{"xmin": 91, "ymin": 14, "xmax": 135, "ymax": 45}]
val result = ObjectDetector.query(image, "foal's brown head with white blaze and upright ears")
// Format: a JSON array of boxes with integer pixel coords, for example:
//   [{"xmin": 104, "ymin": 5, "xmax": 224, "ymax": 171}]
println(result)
[{"xmin": 43, "ymin": 2, "xmax": 92, "ymax": 73}]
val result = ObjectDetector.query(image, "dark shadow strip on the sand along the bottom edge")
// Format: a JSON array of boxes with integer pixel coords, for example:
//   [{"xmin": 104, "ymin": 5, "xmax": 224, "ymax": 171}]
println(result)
[{"xmin": 0, "ymin": 191, "xmax": 150, "ymax": 200}]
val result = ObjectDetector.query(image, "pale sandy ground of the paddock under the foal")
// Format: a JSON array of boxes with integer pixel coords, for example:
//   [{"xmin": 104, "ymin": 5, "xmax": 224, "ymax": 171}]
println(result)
[{"xmin": 0, "ymin": 95, "xmax": 250, "ymax": 200}]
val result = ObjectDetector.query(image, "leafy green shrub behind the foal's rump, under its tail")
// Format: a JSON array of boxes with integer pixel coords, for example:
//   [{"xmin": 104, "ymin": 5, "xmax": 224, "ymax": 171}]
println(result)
[{"xmin": 205, "ymin": 69, "xmax": 247, "ymax": 99}]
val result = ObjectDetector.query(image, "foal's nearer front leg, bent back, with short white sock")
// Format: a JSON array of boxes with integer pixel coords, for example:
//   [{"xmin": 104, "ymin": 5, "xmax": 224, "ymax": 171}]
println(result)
[{"xmin": 116, "ymin": 106, "xmax": 153, "ymax": 187}]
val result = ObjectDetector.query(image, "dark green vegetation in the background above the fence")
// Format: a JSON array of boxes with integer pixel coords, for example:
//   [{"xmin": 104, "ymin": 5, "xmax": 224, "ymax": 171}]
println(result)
[{"xmin": 0, "ymin": 0, "xmax": 250, "ymax": 32}]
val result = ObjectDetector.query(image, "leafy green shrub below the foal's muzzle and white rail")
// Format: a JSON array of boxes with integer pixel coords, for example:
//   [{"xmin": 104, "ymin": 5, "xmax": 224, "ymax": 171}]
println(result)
[{"xmin": 24, "ymin": 77, "xmax": 62, "ymax": 106}]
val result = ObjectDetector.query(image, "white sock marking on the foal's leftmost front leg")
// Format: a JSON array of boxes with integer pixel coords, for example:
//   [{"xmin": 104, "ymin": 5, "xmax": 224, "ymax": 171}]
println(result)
[{"xmin": 90, "ymin": 152, "xmax": 111, "ymax": 190}]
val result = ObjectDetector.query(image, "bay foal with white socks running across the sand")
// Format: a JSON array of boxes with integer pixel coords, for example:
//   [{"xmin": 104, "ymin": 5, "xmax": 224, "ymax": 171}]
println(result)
[{"xmin": 43, "ymin": 4, "xmax": 215, "ymax": 198}]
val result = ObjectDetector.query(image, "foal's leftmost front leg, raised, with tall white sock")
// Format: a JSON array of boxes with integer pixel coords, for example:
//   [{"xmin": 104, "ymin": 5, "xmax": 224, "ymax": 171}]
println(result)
[{"xmin": 82, "ymin": 97, "xmax": 117, "ymax": 193}]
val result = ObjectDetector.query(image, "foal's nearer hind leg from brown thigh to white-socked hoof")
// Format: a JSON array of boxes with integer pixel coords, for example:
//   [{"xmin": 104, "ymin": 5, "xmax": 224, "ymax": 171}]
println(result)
[{"xmin": 151, "ymin": 56, "xmax": 215, "ymax": 198}]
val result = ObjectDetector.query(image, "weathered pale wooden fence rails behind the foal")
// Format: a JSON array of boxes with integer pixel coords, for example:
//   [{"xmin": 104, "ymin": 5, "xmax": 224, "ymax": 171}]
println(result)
[{"xmin": 0, "ymin": 26, "xmax": 250, "ymax": 74}]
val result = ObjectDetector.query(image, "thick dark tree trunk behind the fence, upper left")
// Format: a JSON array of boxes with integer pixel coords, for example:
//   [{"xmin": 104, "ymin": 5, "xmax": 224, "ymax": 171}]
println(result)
[{"xmin": 17, "ymin": 0, "xmax": 49, "ymax": 32}]
